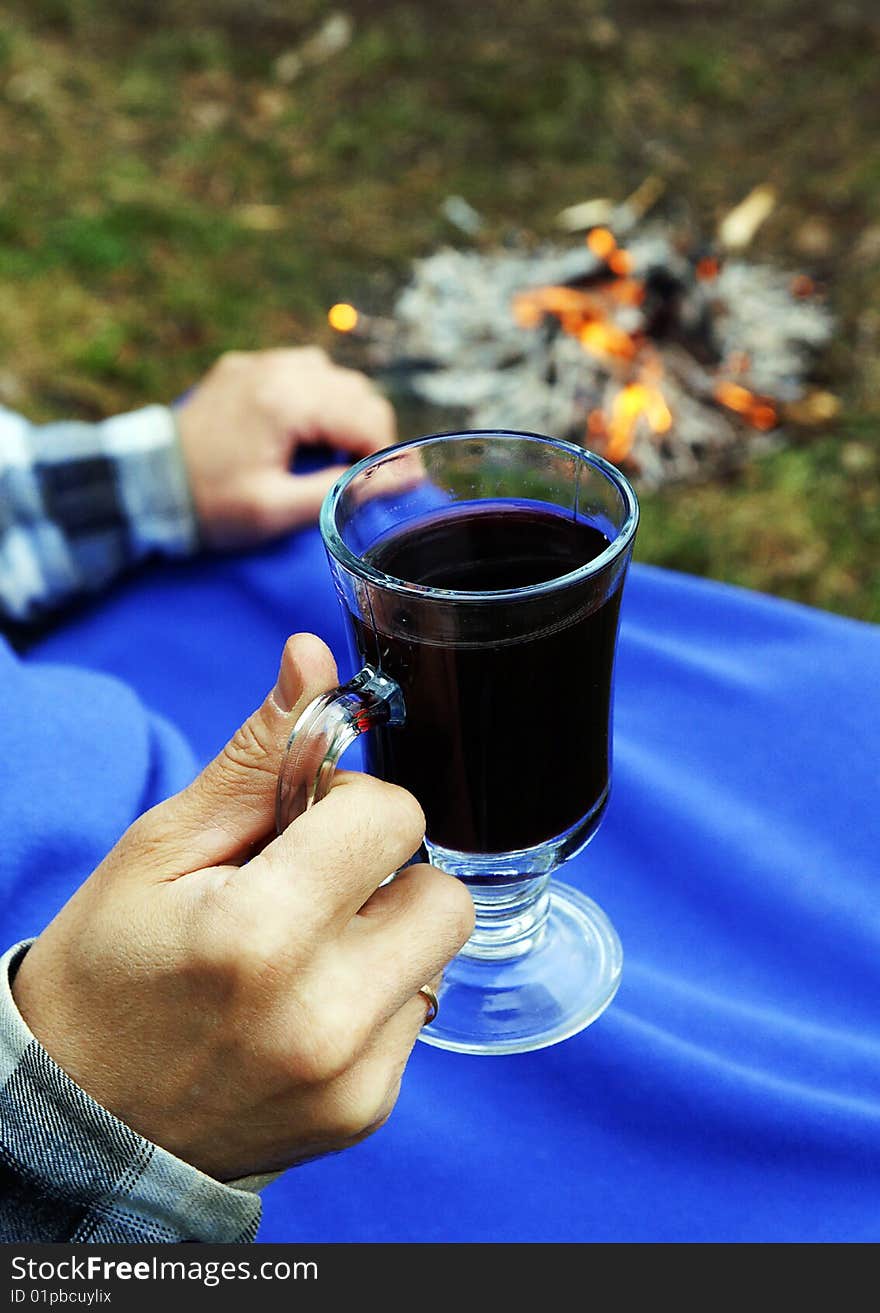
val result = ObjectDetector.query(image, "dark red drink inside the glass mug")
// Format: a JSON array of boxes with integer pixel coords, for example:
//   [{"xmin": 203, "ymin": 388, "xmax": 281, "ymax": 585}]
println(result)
[{"xmin": 352, "ymin": 503, "xmax": 623, "ymax": 853}]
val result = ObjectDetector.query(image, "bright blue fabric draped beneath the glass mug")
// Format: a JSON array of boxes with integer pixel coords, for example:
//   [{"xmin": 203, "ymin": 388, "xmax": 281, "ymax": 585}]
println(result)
[{"xmin": 0, "ymin": 514, "xmax": 880, "ymax": 1241}]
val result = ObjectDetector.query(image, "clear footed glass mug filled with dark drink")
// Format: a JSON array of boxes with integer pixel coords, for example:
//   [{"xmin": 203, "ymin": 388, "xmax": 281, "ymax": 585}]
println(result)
[{"xmin": 277, "ymin": 431, "xmax": 638, "ymax": 1053}]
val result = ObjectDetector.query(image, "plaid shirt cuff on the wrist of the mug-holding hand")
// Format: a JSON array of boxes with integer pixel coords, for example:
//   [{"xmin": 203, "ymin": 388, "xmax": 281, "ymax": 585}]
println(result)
[{"xmin": 0, "ymin": 943, "xmax": 262, "ymax": 1245}]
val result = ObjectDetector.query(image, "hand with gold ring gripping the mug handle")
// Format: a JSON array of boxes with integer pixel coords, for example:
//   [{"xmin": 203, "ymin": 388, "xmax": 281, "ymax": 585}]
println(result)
[{"xmin": 13, "ymin": 634, "xmax": 473, "ymax": 1180}]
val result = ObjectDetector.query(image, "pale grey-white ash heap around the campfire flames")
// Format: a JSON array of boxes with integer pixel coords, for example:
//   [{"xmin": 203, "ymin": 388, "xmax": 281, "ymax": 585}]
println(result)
[{"xmin": 383, "ymin": 230, "xmax": 833, "ymax": 487}]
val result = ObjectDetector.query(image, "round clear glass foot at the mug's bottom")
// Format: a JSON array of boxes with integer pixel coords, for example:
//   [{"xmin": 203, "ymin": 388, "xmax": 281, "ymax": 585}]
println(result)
[{"xmin": 419, "ymin": 881, "xmax": 624, "ymax": 1053}]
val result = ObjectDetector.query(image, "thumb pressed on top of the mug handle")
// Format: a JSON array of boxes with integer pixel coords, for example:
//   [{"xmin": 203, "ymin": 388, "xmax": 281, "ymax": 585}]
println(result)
[{"xmin": 137, "ymin": 634, "xmax": 338, "ymax": 878}]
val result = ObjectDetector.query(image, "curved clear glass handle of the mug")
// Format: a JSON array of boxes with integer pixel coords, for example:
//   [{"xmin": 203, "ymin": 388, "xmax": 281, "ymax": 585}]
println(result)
[{"xmin": 275, "ymin": 666, "xmax": 406, "ymax": 834}]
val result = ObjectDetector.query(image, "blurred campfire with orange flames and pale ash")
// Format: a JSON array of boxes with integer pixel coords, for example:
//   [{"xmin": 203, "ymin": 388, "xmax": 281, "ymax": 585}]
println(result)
[{"xmin": 330, "ymin": 186, "xmax": 837, "ymax": 487}]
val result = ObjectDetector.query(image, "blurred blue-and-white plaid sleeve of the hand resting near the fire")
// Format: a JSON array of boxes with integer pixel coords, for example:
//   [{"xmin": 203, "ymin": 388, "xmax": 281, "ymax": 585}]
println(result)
[{"xmin": 0, "ymin": 406, "xmax": 197, "ymax": 621}]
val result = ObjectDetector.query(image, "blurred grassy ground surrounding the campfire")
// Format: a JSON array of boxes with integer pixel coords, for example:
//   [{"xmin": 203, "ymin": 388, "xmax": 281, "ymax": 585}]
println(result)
[{"xmin": 0, "ymin": 0, "xmax": 880, "ymax": 621}]
